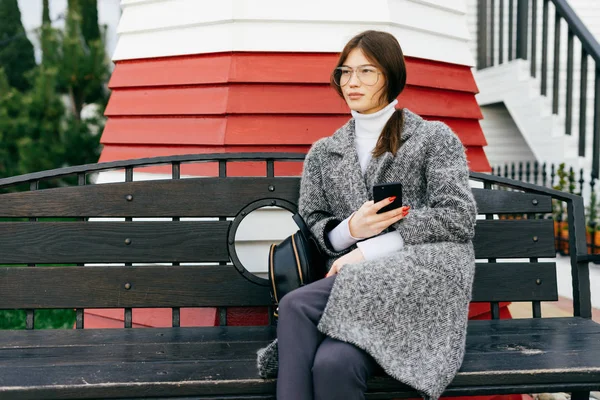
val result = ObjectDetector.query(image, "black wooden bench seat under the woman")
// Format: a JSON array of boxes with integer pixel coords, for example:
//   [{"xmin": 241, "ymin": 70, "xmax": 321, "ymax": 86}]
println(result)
[{"xmin": 0, "ymin": 318, "xmax": 600, "ymax": 399}]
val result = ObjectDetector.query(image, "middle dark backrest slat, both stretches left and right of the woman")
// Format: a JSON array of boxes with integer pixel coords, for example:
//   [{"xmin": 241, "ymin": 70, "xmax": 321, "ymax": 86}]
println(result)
[{"xmin": 0, "ymin": 220, "xmax": 555, "ymax": 264}]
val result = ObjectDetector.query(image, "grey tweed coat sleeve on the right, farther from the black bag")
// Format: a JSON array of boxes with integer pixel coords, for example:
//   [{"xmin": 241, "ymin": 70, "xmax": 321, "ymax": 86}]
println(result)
[{"xmin": 394, "ymin": 123, "xmax": 477, "ymax": 245}]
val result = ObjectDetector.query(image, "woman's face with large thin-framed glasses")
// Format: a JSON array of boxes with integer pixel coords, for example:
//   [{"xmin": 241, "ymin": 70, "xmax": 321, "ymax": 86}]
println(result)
[{"xmin": 340, "ymin": 48, "xmax": 387, "ymax": 114}]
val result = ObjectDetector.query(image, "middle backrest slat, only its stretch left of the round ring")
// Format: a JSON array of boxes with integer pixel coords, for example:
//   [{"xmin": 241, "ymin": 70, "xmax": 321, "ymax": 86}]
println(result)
[{"xmin": 0, "ymin": 221, "xmax": 231, "ymax": 264}]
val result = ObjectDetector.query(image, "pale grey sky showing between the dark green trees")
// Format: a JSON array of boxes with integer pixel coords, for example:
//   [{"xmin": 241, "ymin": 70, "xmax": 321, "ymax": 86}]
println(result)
[{"xmin": 18, "ymin": 0, "xmax": 121, "ymax": 67}]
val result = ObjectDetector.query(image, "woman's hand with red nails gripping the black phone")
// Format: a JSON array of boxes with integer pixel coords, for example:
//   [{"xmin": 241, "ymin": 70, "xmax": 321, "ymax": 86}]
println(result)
[{"xmin": 348, "ymin": 197, "xmax": 410, "ymax": 239}]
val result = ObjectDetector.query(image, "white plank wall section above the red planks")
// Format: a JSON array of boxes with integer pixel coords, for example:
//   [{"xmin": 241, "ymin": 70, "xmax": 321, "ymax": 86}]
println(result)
[{"xmin": 113, "ymin": 0, "xmax": 474, "ymax": 65}]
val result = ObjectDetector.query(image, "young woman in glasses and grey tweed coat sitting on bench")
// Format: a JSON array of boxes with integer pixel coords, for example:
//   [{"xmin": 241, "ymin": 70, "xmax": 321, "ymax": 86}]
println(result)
[{"xmin": 258, "ymin": 31, "xmax": 477, "ymax": 400}]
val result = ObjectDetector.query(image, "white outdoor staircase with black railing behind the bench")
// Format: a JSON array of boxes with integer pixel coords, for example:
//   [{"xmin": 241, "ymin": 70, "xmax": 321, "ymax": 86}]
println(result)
[{"xmin": 467, "ymin": 0, "xmax": 600, "ymax": 178}]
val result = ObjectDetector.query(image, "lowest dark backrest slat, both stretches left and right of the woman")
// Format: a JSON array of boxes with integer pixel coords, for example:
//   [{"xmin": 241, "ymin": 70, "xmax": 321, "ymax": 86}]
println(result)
[{"xmin": 0, "ymin": 263, "xmax": 558, "ymax": 309}]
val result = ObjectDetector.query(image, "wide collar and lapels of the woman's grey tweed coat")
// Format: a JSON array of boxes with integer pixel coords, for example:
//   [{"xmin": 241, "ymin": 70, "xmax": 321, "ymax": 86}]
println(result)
[{"xmin": 329, "ymin": 108, "xmax": 423, "ymax": 209}]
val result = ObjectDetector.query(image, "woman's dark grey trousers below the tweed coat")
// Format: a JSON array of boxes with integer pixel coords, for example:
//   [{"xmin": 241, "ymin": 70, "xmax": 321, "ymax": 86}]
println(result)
[{"xmin": 277, "ymin": 276, "xmax": 377, "ymax": 400}]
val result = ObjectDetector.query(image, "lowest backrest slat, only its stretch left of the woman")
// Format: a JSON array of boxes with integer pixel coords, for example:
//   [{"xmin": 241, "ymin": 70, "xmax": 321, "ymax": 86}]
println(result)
[{"xmin": 0, "ymin": 265, "xmax": 271, "ymax": 309}]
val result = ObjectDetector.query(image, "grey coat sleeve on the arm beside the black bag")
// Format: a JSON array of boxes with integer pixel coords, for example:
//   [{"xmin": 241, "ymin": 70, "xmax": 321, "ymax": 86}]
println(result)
[{"xmin": 298, "ymin": 142, "xmax": 355, "ymax": 257}]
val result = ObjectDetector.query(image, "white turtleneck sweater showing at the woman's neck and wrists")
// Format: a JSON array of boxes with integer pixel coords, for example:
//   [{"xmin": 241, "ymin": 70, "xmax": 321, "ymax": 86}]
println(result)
[{"xmin": 328, "ymin": 100, "xmax": 404, "ymax": 260}]
